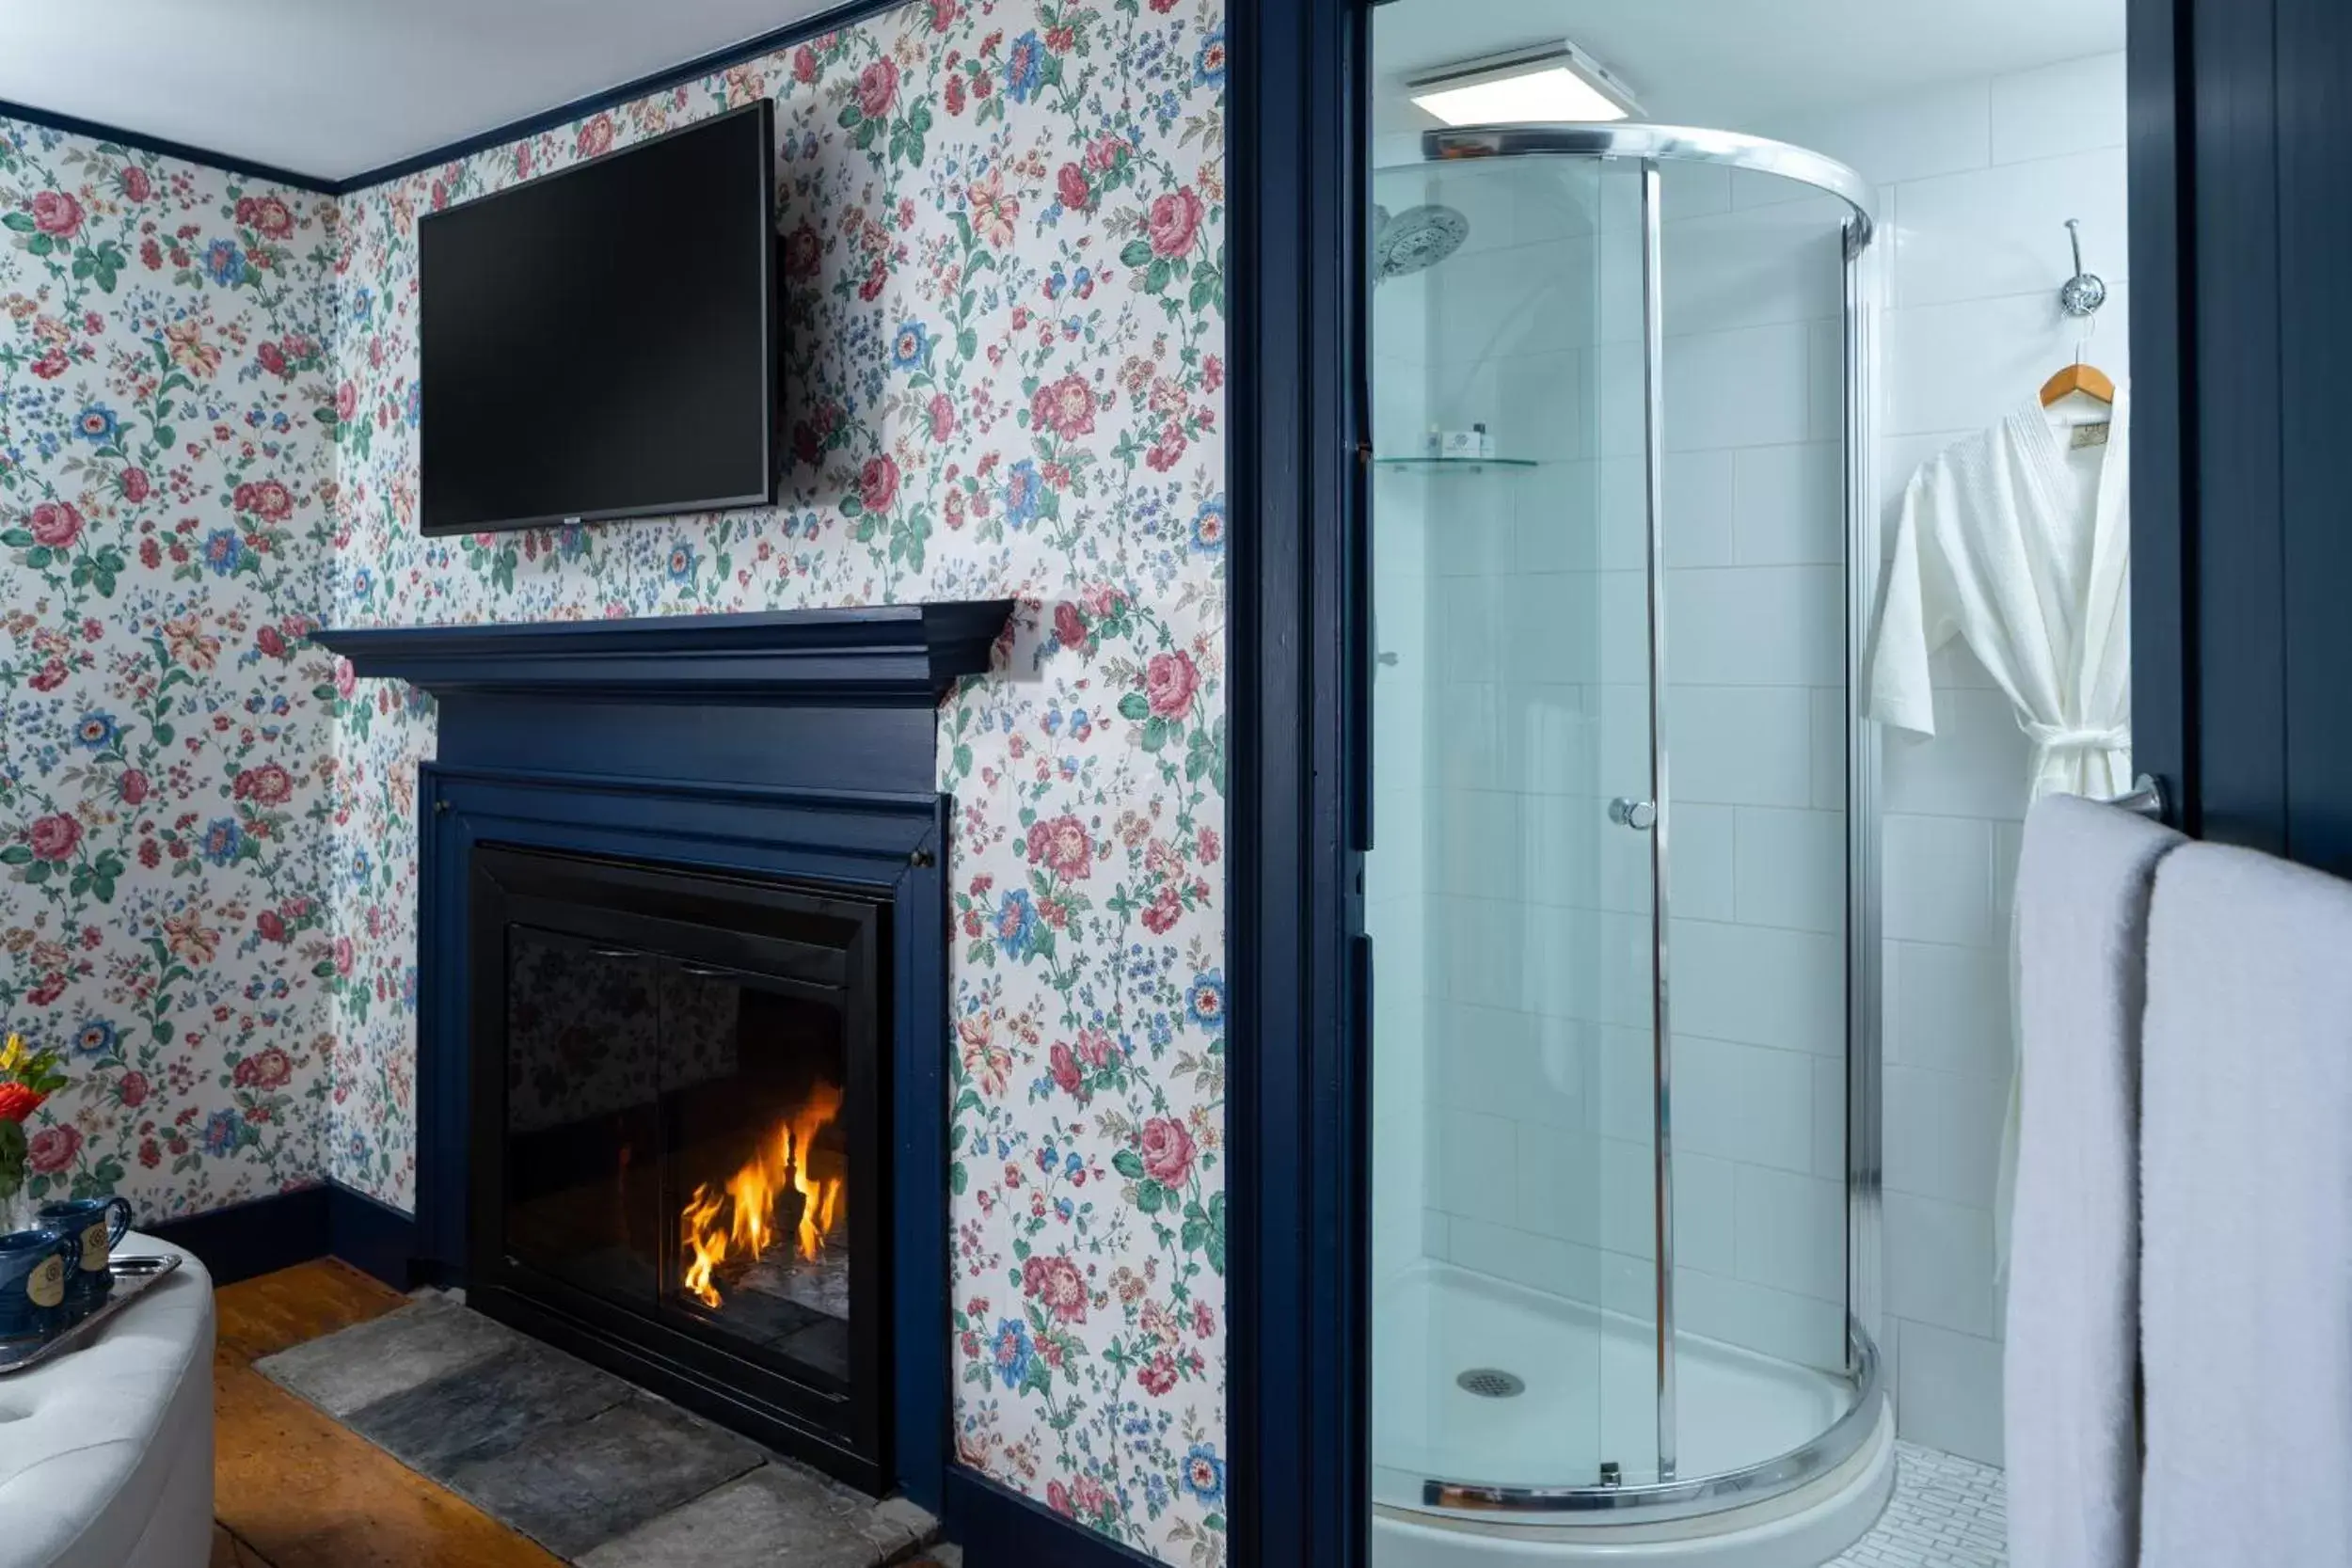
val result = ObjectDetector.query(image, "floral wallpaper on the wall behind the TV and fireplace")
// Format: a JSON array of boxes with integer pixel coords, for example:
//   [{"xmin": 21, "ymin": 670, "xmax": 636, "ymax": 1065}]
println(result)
[{"xmin": 318, "ymin": 0, "xmax": 1226, "ymax": 1566}]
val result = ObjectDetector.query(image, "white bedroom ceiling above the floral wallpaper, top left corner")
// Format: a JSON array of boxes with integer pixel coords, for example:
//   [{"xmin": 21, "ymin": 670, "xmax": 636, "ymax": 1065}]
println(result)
[{"xmin": 0, "ymin": 0, "xmax": 828, "ymax": 179}]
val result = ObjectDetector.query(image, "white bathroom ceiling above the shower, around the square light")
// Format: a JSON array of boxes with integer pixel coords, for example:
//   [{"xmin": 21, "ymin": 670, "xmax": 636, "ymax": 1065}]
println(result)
[{"xmin": 1374, "ymin": 0, "xmax": 2124, "ymax": 132}]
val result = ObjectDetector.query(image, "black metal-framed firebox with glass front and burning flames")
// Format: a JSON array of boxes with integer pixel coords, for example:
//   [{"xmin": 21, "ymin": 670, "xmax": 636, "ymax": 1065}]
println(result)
[{"xmin": 469, "ymin": 844, "xmax": 892, "ymax": 1474}]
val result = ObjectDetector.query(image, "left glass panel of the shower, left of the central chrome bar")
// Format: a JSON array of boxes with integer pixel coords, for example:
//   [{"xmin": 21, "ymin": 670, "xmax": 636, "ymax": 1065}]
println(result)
[{"xmin": 1367, "ymin": 150, "xmax": 1665, "ymax": 1505}]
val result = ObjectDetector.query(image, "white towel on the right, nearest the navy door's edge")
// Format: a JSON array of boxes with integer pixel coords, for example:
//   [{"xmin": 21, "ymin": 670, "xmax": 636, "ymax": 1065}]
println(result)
[{"xmin": 2140, "ymin": 844, "xmax": 2352, "ymax": 1568}]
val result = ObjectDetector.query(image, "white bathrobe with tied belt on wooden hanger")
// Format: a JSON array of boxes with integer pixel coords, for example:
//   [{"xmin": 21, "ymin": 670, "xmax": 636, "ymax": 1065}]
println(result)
[{"xmin": 1867, "ymin": 390, "xmax": 2131, "ymax": 1272}]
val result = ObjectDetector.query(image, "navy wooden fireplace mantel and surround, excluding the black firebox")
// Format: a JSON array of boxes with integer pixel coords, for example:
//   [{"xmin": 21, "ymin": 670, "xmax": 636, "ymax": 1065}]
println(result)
[{"xmin": 315, "ymin": 599, "xmax": 1014, "ymax": 1512}]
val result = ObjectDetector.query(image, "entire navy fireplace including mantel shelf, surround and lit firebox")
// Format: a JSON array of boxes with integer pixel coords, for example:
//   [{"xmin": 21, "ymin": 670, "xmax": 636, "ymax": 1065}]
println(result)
[{"xmin": 320, "ymin": 602, "xmax": 1011, "ymax": 1510}]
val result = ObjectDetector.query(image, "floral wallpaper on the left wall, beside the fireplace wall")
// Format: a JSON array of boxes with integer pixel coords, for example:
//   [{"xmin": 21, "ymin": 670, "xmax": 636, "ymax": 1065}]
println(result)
[{"xmin": 0, "ymin": 119, "xmax": 337, "ymax": 1220}]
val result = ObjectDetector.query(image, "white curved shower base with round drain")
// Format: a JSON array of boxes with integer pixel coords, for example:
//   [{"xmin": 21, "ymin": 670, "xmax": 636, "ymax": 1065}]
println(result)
[{"xmin": 1372, "ymin": 1260, "xmax": 1894, "ymax": 1568}]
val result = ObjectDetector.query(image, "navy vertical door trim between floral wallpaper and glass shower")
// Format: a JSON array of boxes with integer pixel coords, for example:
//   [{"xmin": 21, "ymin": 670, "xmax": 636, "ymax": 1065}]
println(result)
[{"xmin": 1226, "ymin": 0, "xmax": 1372, "ymax": 1568}]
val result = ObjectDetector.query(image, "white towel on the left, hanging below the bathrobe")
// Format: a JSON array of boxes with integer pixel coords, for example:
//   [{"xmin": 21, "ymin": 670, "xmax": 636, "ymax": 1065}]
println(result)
[{"xmin": 2002, "ymin": 795, "xmax": 2187, "ymax": 1568}]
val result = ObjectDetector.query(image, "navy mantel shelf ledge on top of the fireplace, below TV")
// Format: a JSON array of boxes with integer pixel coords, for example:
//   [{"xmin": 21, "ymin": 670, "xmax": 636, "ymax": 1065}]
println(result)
[{"xmin": 313, "ymin": 599, "xmax": 1014, "ymax": 707}]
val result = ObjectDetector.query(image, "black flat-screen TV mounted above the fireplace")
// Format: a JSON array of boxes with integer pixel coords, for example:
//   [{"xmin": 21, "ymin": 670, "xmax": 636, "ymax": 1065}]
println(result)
[{"xmin": 417, "ymin": 99, "xmax": 776, "ymax": 533}]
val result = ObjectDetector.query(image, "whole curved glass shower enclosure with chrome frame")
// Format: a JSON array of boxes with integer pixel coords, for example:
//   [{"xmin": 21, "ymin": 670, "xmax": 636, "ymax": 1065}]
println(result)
[{"xmin": 1367, "ymin": 124, "xmax": 1882, "ymax": 1561}]
